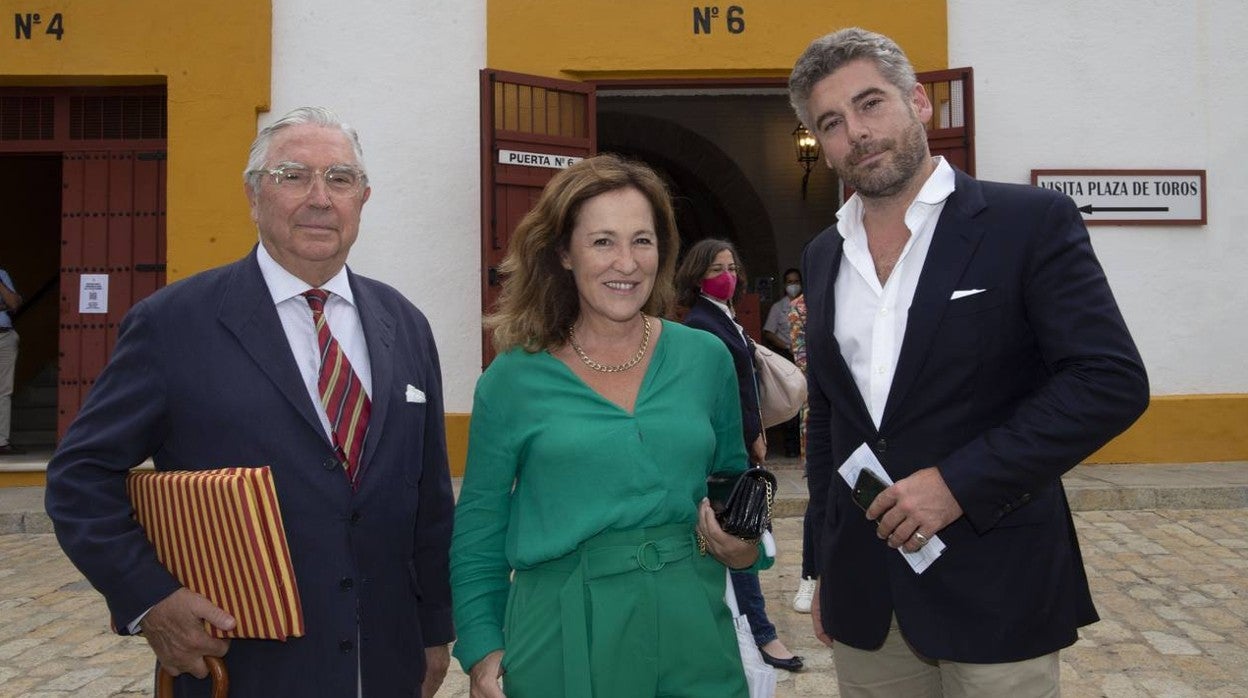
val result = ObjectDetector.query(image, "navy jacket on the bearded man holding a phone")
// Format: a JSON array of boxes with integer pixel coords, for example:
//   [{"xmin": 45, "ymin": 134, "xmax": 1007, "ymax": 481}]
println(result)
[{"xmin": 802, "ymin": 166, "xmax": 1148, "ymax": 663}]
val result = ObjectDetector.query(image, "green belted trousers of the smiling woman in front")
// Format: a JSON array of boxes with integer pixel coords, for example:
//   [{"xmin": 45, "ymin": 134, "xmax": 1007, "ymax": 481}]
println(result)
[{"xmin": 503, "ymin": 523, "xmax": 749, "ymax": 698}]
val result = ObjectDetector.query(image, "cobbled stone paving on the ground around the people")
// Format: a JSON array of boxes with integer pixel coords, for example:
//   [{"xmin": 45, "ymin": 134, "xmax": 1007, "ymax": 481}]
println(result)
[{"xmin": 0, "ymin": 508, "xmax": 1248, "ymax": 698}]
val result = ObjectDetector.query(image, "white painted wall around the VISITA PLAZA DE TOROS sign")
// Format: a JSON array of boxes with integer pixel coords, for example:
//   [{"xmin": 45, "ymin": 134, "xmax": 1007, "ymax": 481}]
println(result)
[{"xmin": 948, "ymin": 0, "xmax": 1248, "ymax": 395}]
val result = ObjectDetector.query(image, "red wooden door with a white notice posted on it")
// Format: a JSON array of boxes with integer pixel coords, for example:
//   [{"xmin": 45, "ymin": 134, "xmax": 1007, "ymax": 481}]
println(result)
[{"xmin": 56, "ymin": 150, "xmax": 166, "ymax": 438}]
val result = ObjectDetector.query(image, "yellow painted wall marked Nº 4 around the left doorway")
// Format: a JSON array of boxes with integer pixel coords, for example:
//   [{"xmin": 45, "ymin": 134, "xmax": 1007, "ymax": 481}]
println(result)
[{"xmin": 0, "ymin": 0, "xmax": 272, "ymax": 281}]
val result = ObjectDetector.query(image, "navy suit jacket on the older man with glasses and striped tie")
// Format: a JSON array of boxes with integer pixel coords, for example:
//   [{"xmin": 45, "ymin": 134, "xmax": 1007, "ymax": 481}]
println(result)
[{"xmin": 46, "ymin": 251, "xmax": 453, "ymax": 697}]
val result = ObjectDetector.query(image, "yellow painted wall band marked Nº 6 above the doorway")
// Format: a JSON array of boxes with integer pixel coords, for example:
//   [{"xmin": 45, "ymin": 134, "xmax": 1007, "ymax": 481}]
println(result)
[{"xmin": 487, "ymin": 0, "xmax": 948, "ymax": 80}]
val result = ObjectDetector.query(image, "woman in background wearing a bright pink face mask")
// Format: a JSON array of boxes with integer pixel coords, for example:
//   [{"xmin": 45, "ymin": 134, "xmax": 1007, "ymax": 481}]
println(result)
[{"xmin": 676, "ymin": 238, "xmax": 802, "ymax": 672}]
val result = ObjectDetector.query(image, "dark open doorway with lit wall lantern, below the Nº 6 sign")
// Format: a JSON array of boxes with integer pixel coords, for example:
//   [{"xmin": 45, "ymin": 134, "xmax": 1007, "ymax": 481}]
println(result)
[{"xmin": 598, "ymin": 82, "xmax": 839, "ymax": 337}]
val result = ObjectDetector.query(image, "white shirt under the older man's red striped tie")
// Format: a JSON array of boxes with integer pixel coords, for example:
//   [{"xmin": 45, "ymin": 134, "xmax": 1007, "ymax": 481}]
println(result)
[{"xmin": 256, "ymin": 245, "xmax": 373, "ymax": 441}]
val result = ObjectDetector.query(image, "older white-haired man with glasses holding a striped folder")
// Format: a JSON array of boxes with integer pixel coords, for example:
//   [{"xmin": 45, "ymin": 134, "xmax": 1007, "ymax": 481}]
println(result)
[{"xmin": 46, "ymin": 107, "xmax": 453, "ymax": 698}]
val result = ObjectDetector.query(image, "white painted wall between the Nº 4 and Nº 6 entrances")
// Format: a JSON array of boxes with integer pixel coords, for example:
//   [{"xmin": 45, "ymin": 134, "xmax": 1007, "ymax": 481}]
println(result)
[{"xmin": 268, "ymin": 0, "xmax": 485, "ymax": 412}]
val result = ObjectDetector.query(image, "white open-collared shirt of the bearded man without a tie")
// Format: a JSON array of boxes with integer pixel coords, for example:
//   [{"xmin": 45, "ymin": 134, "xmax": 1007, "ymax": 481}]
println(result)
[{"xmin": 832, "ymin": 156, "xmax": 953, "ymax": 428}]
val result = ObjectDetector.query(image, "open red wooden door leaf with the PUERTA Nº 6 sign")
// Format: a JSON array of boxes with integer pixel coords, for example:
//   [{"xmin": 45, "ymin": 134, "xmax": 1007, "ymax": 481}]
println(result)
[{"xmin": 480, "ymin": 69, "xmax": 598, "ymax": 367}]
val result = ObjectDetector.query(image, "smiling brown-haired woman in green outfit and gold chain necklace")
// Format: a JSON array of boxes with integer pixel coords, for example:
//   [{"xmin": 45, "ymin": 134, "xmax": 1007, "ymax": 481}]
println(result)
[{"xmin": 451, "ymin": 155, "xmax": 759, "ymax": 698}]
